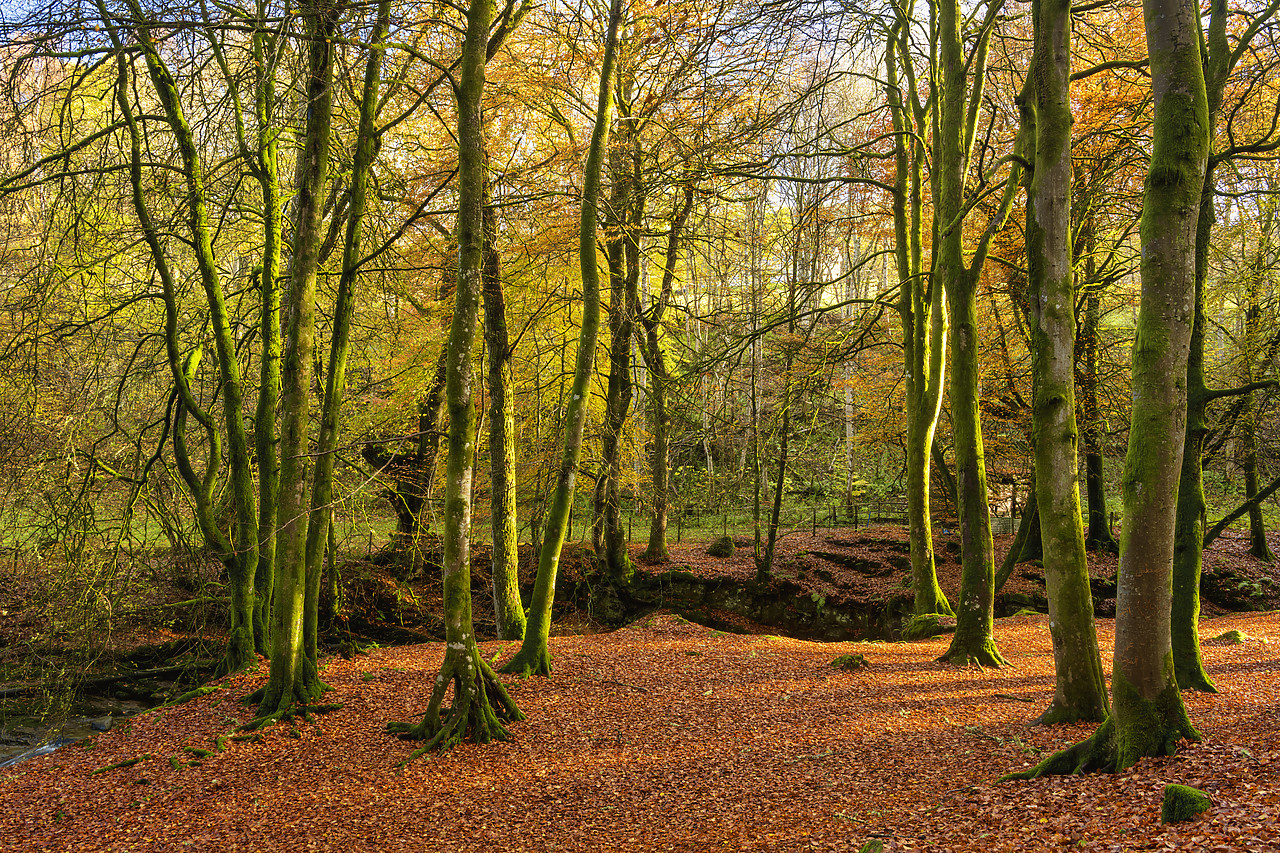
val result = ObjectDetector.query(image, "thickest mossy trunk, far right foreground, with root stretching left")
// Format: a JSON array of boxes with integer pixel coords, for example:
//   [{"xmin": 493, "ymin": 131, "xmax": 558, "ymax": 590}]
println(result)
[{"xmin": 1003, "ymin": 0, "xmax": 1208, "ymax": 777}]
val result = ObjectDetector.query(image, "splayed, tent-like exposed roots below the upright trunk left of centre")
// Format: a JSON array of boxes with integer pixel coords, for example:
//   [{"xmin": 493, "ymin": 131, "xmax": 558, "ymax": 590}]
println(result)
[{"xmin": 387, "ymin": 640, "xmax": 525, "ymax": 767}]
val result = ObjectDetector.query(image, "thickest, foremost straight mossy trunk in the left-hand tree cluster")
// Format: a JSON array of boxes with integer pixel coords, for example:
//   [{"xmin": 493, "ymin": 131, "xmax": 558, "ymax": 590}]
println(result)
[{"xmin": 256, "ymin": 1, "xmax": 338, "ymax": 722}]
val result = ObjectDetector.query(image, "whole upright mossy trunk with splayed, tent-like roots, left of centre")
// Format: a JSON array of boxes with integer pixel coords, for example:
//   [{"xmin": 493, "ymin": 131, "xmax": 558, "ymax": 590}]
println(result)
[{"xmin": 388, "ymin": 0, "xmax": 524, "ymax": 754}]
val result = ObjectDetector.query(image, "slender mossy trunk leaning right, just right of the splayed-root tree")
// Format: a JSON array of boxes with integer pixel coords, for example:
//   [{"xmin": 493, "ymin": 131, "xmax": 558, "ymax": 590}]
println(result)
[{"xmin": 502, "ymin": 0, "xmax": 622, "ymax": 675}]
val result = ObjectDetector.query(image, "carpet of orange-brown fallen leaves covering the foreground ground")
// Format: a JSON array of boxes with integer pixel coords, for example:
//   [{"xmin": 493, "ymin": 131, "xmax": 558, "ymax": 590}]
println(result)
[{"xmin": 0, "ymin": 601, "xmax": 1280, "ymax": 853}]
